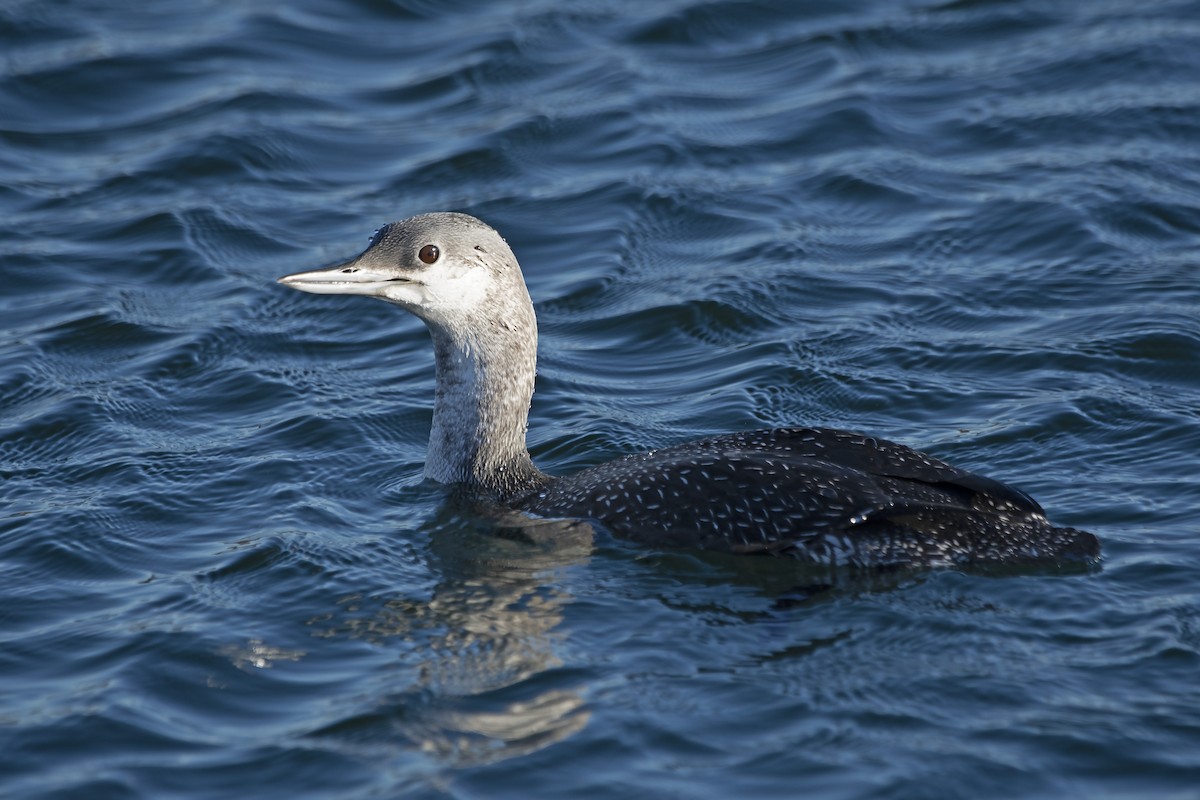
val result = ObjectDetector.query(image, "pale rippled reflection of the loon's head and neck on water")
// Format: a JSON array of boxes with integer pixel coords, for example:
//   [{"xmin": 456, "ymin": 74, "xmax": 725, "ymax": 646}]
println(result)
[{"xmin": 304, "ymin": 499, "xmax": 592, "ymax": 766}]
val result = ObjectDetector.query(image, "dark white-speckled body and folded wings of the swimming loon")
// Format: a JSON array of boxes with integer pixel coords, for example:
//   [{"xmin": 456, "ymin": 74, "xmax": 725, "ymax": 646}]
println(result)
[{"xmin": 521, "ymin": 428, "xmax": 1096, "ymax": 564}]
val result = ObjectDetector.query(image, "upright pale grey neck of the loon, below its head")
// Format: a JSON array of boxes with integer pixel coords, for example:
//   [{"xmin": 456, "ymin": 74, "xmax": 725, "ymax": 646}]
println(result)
[{"xmin": 425, "ymin": 302, "xmax": 545, "ymax": 497}]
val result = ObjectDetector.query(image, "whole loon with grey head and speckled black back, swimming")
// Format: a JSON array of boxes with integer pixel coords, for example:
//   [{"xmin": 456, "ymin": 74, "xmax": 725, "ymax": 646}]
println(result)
[{"xmin": 278, "ymin": 212, "xmax": 1099, "ymax": 569}]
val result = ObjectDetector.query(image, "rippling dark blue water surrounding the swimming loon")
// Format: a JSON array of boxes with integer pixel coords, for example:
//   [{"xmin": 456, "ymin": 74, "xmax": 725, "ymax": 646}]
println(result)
[{"xmin": 0, "ymin": 0, "xmax": 1200, "ymax": 799}]
